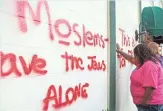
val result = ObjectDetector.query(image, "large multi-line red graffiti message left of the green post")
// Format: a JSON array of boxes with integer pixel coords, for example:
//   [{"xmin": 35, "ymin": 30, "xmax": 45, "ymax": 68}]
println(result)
[{"xmin": 12, "ymin": 0, "xmax": 104, "ymax": 111}]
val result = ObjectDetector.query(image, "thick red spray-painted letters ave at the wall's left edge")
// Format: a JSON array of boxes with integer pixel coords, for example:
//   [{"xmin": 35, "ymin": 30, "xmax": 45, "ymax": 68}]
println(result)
[{"xmin": 0, "ymin": 52, "xmax": 47, "ymax": 77}]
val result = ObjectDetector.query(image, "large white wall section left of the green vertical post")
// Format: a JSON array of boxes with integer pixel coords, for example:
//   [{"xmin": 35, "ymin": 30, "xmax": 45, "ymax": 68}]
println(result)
[{"xmin": 0, "ymin": 0, "xmax": 108, "ymax": 111}]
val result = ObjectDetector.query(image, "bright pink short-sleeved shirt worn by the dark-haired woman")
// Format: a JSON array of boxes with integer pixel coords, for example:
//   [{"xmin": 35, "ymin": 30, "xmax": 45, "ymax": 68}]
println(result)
[{"xmin": 130, "ymin": 61, "xmax": 163, "ymax": 105}]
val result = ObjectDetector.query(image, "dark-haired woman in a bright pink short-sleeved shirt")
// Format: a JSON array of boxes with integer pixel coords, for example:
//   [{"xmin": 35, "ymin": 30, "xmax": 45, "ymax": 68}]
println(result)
[{"xmin": 121, "ymin": 43, "xmax": 163, "ymax": 111}]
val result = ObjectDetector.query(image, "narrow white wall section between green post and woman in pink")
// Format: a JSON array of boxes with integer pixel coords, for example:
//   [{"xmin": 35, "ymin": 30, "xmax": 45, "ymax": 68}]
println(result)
[{"xmin": 116, "ymin": 0, "xmax": 139, "ymax": 111}]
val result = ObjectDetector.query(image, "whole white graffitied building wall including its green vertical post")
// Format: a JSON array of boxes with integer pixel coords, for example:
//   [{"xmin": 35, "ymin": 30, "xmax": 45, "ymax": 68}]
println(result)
[{"xmin": 0, "ymin": 0, "xmax": 163, "ymax": 111}]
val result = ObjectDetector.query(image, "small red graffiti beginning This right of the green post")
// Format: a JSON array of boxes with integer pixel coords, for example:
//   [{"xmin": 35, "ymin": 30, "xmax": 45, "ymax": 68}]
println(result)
[{"xmin": 117, "ymin": 28, "xmax": 136, "ymax": 68}]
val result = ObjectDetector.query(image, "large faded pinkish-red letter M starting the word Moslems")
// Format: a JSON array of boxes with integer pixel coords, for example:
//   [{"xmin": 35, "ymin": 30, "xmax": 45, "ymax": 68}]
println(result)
[{"xmin": 16, "ymin": 0, "xmax": 54, "ymax": 40}]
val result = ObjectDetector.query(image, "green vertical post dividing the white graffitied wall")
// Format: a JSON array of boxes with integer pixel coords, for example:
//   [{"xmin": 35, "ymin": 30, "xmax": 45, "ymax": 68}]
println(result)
[{"xmin": 109, "ymin": 0, "xmax": 116, "ymax": 111}]
